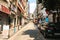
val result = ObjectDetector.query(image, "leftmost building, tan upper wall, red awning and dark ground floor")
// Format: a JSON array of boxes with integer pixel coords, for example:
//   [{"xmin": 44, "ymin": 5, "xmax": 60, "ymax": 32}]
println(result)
[{"xmin": 0, "ymin": 0, "xmax": 11, "ymax": 31}]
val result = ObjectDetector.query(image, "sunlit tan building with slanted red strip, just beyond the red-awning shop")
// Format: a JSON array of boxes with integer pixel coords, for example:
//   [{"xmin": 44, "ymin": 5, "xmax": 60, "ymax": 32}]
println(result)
[{"xmin": 10, "ymin": 0, "xmax": 27, "ymax": 37}]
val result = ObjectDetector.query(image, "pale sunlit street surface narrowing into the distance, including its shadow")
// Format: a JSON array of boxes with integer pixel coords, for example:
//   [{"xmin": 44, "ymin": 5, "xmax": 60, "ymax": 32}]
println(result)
[{"xmin": 8, "ymin": 22, "xmax": 44, "ymax": 40}]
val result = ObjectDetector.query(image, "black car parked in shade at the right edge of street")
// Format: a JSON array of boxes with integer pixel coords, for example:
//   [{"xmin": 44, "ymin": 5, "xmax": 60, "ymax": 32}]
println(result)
[{"xmin": 39, "ymin": 22, "xmax": 60, "ymax": 37}]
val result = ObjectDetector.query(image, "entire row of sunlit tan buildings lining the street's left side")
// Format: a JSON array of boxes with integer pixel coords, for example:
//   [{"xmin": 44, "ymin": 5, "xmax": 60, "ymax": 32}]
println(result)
[{"xmin": 0, "ymin": 0, "xmax": 28, "ymax": 38}]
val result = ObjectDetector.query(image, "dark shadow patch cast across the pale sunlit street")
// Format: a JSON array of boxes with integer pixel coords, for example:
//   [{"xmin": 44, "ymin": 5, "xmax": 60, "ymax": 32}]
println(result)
[{"xmin": 22, "ymin": 30, "xmax": 43, "ymax": 40}]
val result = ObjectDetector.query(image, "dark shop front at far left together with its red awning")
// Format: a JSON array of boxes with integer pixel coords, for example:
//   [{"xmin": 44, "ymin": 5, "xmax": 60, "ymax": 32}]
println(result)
[{"xmin": 0, "ymin": 5, "xmax": 10, "ymax": 34}]
